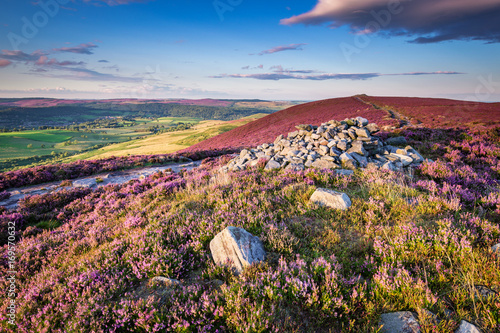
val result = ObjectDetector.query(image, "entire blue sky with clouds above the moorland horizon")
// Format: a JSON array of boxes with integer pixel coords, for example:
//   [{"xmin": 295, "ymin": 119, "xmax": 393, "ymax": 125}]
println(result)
[{"xmin": 0, "ymin": 0, "xmax": 500, "ymax": 102}]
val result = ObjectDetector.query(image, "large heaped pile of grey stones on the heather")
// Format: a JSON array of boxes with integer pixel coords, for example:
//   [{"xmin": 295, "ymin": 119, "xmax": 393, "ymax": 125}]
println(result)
[{"xmin": 224, "ymin": 117, "xmax": 424, "ymax": 171}]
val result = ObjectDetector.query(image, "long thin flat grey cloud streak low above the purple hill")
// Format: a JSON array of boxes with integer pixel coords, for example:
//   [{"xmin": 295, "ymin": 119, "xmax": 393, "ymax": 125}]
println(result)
[{"xmin": 211, "ymin": 70, "xmax": 464, "ymax": 81}]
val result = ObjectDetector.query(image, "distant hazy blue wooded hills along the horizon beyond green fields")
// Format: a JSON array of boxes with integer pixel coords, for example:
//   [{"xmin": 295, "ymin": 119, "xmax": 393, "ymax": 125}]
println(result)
[{"xmin": 0, "ymin": 98, "xmax": 297, "ymax": 130}]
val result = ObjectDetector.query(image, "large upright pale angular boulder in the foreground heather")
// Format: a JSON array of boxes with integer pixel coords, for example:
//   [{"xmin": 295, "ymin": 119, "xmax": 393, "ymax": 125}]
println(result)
[{"xmin": 210, "ymin": 227, "xmax": 266, "ymax": 274}]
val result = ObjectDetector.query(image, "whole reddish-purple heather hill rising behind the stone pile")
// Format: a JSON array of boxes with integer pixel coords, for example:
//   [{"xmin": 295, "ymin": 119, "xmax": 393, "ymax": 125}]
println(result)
[{"xmin": 181, "ymin": 95, "xmax": 500, "ymax": 152}]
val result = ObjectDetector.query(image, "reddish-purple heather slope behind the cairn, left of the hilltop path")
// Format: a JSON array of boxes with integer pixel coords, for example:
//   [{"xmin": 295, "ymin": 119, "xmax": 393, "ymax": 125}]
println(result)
[{"xmin": 181, "ymin": 97, "xmax": 398, "ymax": 152}]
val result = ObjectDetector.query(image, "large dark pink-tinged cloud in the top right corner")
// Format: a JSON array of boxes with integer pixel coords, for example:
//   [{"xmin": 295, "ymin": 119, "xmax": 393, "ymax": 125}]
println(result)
[{"xmin": 281, "ymin": 0, "xmax": 500, "ymax": 44}]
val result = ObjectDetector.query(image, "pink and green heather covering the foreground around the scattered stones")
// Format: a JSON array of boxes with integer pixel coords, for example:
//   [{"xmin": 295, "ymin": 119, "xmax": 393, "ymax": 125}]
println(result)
[{"xmin": 0, "ymin": 124, "xmax": 500, "ymax": 332}]
